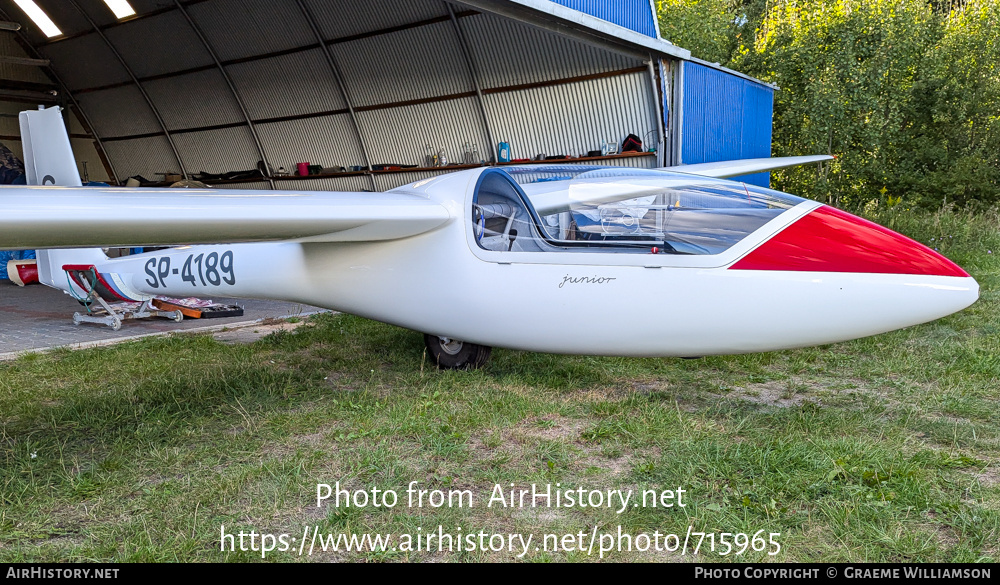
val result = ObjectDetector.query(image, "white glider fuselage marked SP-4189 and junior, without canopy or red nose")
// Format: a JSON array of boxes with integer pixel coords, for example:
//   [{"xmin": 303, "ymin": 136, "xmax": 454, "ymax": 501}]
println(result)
[{"xmin": 70, "ymin": 171, "xmax": 978, "ymax": 356}]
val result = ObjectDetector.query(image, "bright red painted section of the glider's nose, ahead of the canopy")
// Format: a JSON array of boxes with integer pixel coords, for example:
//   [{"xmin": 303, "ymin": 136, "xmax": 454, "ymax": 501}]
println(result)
[{"xmin": 732, "ymin": 205, "xmax": 969, "ymax": 277}]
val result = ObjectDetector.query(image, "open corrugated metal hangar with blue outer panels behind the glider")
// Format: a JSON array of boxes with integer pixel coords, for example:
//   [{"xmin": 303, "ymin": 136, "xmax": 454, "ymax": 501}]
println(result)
[{"xmin": 0, "ymin": 0, "xmax": 775, "ymax": 277}]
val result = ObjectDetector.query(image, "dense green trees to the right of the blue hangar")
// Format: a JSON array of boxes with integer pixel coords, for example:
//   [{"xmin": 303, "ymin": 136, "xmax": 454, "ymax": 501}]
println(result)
[{"xmin": 660, "ymin": 0, "xmax": 1000, "ymax": 207}]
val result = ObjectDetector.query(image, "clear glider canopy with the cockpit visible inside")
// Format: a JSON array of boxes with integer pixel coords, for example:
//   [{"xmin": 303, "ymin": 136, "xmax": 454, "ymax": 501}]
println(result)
[{"xmin": 470, "ymin": 165, "xmax": 803, "ymax": 254}]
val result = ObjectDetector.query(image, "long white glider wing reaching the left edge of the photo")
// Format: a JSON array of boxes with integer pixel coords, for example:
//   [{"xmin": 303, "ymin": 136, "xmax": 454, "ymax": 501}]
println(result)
[{"xmin": 0, "ymin": 186, "xmax": 450, "ymax": 249}]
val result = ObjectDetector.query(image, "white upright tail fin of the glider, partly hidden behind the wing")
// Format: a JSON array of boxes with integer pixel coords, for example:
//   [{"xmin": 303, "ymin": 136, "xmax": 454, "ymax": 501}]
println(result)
[{"xmin": 18, "ymin": 108, "xmax": 108, "ymax": 292}]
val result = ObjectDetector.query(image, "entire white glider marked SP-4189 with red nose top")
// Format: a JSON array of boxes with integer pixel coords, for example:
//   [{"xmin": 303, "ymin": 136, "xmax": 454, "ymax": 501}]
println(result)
[{"xmin": 0, "ymin": 104, "xmax": 979, "ymax": 367}]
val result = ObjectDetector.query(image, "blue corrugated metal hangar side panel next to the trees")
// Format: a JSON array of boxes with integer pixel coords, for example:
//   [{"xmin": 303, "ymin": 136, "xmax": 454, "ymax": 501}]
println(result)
[{"xmin": 681, "ymin": 61, "xmax": 774, "ymax": 187}]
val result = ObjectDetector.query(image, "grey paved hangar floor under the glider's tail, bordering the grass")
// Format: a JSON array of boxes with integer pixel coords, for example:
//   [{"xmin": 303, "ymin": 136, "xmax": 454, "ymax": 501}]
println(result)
[{"xmin": 0, "ymin": 280, "xmax": 322, "ymax": 359}]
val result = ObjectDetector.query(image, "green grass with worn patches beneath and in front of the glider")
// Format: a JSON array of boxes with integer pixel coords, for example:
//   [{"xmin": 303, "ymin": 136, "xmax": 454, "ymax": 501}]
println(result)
[{"xmin": 0, "ymin": 210, "xmax": 1000, "ymax": 562}]
